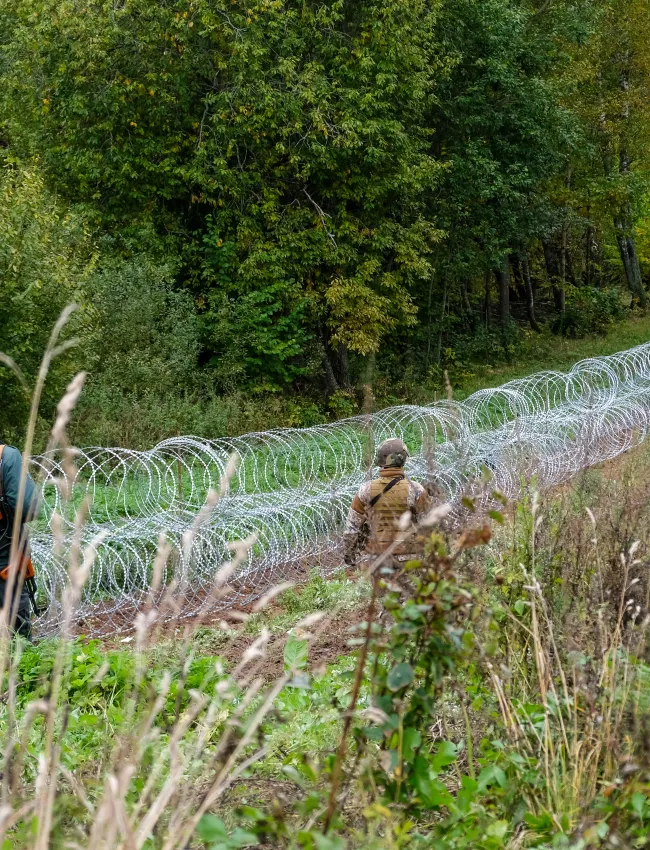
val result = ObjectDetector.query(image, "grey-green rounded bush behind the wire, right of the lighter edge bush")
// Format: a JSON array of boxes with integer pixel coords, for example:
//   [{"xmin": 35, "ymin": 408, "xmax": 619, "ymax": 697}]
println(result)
[{"xmin": 71, "ymin": 252, "xmax": 199, "ymax": 446}]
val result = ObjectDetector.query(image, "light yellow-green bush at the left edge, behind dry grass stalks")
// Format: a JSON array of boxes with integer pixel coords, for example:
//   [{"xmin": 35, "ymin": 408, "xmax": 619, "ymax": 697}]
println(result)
[{"xmin": 0, "ymin": 163, "xmax": 95, "ymax": 442}]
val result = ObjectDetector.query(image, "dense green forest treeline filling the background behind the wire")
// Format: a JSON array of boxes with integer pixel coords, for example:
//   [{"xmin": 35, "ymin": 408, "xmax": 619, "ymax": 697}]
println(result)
[{"xmin": 0, "ymin": 0, "xmax": 650, "ymax": 444}]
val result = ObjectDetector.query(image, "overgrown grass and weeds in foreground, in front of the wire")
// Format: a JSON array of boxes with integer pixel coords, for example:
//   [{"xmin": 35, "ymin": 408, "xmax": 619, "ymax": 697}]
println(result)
[{"xmin": 0, "ymin": 440, "xmax": 650, "ymax": 850}]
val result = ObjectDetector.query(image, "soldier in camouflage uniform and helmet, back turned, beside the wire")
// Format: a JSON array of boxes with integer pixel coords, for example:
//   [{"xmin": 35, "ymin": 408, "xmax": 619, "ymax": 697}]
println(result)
[{"xmin": 343, "ymin": 439, "xmax": 431, "ymax": 567}]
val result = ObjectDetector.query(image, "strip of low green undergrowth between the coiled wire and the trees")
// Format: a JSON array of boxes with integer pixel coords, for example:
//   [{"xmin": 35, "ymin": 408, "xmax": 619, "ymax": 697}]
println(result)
[{"xmin": 55, "ymin": 308, "xmax": 650, "ymax": 449}]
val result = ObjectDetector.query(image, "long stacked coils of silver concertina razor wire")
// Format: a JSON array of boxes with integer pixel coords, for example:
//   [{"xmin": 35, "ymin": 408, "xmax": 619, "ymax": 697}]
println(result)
[{"xmin": 31, "ymin": 344, "xmax": 650, "ymax": 635}]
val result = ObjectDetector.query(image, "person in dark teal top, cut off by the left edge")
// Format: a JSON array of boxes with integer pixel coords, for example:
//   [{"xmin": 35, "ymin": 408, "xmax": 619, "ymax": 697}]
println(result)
[{"xmin": 0, "ymin": 445, "xmax": 40, "ymax": 640}]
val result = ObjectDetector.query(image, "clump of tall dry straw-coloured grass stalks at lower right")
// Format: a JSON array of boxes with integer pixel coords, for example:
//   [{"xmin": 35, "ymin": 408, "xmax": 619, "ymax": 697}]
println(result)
[{"xmin": 488, "ymin": 468, "xmax": 650, "ymax": 829}]
